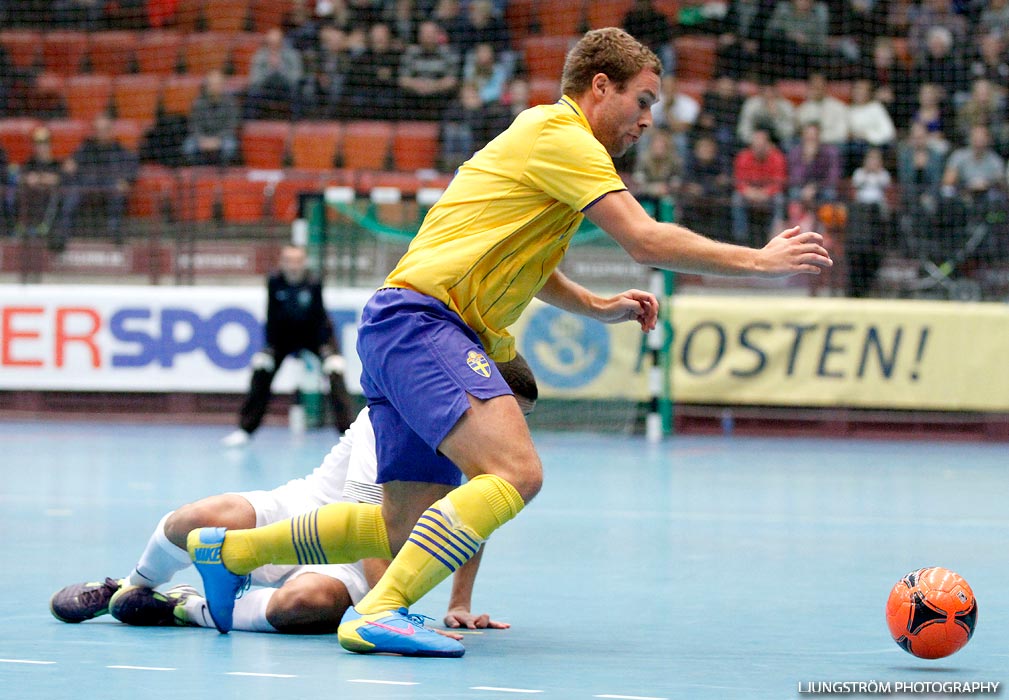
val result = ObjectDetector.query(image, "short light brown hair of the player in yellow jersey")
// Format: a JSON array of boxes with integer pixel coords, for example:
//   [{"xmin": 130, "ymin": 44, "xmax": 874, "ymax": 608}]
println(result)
[{"xmin": 561, "ymin": 27, "xmax": 662, "ymax": 97}]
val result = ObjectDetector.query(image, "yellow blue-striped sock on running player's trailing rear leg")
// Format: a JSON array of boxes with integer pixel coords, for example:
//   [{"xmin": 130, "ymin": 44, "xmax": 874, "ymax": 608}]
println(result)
[{"xmin": 221, "ymin": 503, "xmax": 393, "ymax": 575}]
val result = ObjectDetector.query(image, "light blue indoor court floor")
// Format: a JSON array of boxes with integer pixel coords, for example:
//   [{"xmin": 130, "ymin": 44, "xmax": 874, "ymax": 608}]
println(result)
[{"xmin": 0, "ymin": 421, "xmax": 1009, "ymax": 700}]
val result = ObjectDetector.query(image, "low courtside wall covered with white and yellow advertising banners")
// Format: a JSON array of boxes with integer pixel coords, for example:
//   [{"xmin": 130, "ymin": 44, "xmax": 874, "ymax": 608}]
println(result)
[{"xmin": 0, "ymin": 284, "xmax": 1009, "ymax": 439}]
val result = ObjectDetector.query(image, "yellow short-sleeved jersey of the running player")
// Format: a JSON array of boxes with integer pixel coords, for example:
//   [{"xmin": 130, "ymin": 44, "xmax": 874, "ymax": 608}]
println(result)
[{"xmin": 385, "ymin": 97, "xmax": 626, "ymax": 361}]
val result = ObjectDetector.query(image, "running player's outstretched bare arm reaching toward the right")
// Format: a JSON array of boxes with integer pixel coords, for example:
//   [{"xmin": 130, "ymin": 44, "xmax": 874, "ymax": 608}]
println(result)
[{"xmin": 585, "ymin": 191, "xmax": 832, "ymax": 277}]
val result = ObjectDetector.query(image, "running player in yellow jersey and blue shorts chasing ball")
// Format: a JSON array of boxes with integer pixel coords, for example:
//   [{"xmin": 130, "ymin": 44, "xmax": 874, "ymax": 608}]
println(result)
[{"xmin": 188, "ymin": 27, "xmax": 831, "ymax": 657}]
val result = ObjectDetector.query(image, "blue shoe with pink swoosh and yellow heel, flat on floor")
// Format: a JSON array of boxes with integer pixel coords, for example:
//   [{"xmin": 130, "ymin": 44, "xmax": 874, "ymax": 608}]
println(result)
[{"xmin": 337, "ymin": 607, "xmax": 466, "ymax": 658}]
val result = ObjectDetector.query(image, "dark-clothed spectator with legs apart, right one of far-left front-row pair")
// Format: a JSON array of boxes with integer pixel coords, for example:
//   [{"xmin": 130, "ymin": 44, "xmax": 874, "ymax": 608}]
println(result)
[{"xmin": 51, "ymin": 114, "xmax": 138, "ymax": 250}]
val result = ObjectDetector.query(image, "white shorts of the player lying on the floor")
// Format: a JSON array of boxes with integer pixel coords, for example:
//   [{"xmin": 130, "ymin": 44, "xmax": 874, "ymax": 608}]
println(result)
[{"xmin": 236, "ymin": 479, "xmax": 368, "ymax": 604}]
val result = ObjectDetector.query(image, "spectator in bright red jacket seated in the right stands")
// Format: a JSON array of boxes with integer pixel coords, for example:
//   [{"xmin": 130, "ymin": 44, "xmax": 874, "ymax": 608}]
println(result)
[{"xmin": 732, "ymin": 127, "xmax": 788, "ymax": 245}]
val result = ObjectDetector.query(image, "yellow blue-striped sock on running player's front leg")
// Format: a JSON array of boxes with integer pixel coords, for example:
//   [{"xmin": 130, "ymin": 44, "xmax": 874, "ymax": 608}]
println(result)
[{"xmin": 355, "ymin": 474, "xmax": 526, "ymax": 613}]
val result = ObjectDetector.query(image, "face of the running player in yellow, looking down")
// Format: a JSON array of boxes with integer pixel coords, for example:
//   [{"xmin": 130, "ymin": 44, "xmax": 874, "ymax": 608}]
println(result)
[{"xmin": 592, "ymin": 69, "xmax": 659, "ymax": 157}]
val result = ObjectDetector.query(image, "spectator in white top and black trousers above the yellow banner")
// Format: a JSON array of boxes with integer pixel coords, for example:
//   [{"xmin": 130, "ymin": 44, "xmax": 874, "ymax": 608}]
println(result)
[{"xmin": 845, "ymin": 148, "xmax": 891, "ymax": 298}]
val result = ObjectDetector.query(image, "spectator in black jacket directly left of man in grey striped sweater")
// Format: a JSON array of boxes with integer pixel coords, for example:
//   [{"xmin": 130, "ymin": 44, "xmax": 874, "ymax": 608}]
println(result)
[{"xmin": 345, "ymin": 22, "xmax": 402, "ymax": 119}]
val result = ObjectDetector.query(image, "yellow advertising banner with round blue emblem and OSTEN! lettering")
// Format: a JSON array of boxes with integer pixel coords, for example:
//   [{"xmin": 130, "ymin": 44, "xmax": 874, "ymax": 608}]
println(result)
[{"xmin": 514, "ymin": 297, "xmax": 1009, "ymax": 412}]
